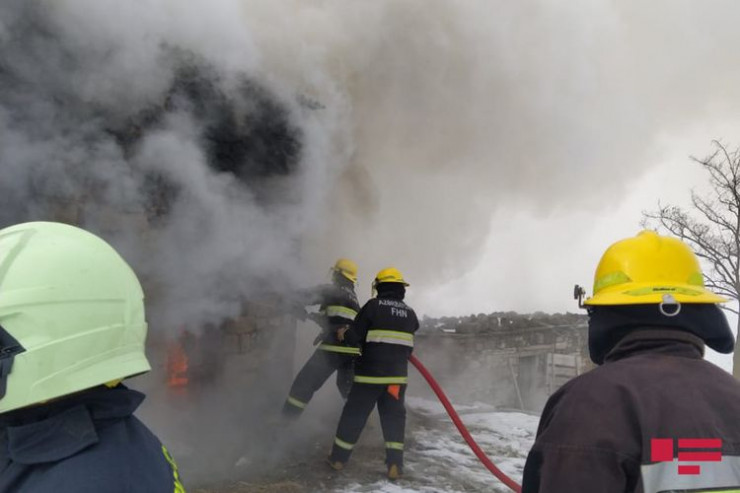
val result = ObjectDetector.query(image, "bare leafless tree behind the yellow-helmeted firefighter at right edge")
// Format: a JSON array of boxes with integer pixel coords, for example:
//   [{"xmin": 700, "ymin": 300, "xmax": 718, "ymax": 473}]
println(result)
[{"xmin": 642, "ymin": 140, "xmax": 740, "ymax": 379}]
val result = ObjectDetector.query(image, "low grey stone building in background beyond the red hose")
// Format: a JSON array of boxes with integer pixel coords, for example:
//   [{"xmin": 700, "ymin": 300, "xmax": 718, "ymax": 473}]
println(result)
[{"xmin": 416, "ymin": 312, "xmax": 593, "ymax": 411}]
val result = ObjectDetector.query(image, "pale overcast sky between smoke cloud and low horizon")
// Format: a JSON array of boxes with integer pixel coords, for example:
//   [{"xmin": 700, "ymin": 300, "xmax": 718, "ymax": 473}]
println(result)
[{"xmin": 409, "ymin": 127, "xmax": 740, "ymax": 371}]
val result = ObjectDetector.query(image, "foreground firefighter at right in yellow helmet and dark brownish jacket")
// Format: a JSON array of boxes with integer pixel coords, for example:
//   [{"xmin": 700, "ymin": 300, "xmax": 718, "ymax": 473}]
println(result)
[{"xmin": 522, "ymin": 231, "xmax": 740, "ymax": 493}]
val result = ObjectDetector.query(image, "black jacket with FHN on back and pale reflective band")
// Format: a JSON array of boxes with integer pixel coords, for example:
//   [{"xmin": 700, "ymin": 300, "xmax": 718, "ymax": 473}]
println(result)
[{"xmin": 346, "ymin": 292, "xmax": 419, "ymax": 384}]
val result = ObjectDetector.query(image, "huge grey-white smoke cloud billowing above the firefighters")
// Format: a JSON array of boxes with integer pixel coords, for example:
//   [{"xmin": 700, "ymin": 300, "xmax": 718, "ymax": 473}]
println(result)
[{"xmin": 0, "ymin": 0, "xmax": 738, "ymax": 316}]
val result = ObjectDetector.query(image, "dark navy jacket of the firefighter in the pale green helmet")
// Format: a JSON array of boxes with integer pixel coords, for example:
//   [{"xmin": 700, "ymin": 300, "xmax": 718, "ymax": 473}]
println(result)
[{"xmin": 0, "ymin": 385, "xmax": 185, "ymax": 493}]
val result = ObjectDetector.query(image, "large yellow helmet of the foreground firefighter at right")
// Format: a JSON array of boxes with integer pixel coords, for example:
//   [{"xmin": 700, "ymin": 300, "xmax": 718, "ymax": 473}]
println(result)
[{"xmin": 584, "ymin": 231, "xmax": 728, "ymax": 306}]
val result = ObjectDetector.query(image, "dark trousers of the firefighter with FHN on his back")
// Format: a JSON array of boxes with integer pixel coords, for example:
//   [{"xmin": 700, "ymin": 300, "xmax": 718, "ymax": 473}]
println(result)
[{"xmin": 329, "ymin": 383, "xmax": 406, "ymax": 467}]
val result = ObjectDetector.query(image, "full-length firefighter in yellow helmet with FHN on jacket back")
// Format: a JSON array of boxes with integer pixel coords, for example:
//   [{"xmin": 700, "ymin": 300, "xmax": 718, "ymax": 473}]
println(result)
[{"xmin": 328, "ymin": 267, "xmax": 419, "ymax": 479}]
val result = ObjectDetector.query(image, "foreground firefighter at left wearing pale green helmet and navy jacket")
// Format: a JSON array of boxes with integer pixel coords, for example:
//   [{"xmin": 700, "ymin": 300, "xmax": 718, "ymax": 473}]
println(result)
[{"xmin": 0, "ymin": 222, "xmax": 185, "ymax": 493}]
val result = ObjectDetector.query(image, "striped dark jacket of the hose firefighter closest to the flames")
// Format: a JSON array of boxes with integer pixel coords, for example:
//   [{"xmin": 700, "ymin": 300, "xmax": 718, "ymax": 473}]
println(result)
[{"xmin": 303, "ymin": 281, "xmax": 360, "ymax": 355}]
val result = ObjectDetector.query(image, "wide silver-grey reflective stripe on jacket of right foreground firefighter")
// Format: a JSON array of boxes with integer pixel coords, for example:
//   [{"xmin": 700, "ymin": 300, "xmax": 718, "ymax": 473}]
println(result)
[{"xmin": 641, "ymin": 455, "xmax": 740, "ymax": 493}]
